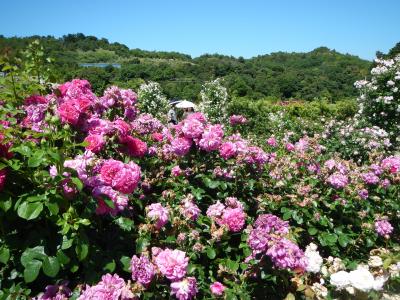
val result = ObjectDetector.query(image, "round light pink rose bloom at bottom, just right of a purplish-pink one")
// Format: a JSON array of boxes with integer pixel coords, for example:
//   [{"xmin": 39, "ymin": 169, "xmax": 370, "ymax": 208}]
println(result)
[{"xmin": 154, "ymin": 248, "xmax": 189, "ymax": 281}]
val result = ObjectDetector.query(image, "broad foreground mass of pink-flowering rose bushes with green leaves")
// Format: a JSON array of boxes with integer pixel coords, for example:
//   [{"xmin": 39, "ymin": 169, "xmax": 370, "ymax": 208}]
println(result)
[{"xmin": 0, "ymin": 79, "xmax": 400, "ymax": 299}]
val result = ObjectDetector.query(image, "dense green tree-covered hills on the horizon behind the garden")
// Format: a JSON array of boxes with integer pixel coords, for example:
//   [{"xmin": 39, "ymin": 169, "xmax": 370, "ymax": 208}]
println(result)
[{"xmin": 0, "ymin": 33, "xmax": 376, "ymax": 101}]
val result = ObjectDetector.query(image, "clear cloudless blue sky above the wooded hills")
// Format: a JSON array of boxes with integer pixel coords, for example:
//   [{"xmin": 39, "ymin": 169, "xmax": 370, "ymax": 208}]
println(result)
[{"xmin": 0, "ymin": 0, "xmax": 400, "ymax": 59}]
